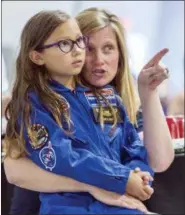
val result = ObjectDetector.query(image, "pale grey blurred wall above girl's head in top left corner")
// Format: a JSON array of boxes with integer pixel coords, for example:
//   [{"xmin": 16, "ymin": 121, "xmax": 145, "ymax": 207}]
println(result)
[{"xmin": 2, "ymin": 1, "xmax": 75, "ymax": 47}]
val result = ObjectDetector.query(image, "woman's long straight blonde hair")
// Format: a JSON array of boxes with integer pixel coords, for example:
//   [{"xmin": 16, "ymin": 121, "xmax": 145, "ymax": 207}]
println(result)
[{"xmin": 76, "ymin": 8, "xmax": 139, "ymax": 124}]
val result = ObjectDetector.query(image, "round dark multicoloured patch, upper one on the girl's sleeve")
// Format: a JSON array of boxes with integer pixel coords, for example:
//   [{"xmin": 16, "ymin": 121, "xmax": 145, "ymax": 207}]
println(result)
[{"xmin": 28, "ymin": 124, "xmax": 49, "ymax": 149}]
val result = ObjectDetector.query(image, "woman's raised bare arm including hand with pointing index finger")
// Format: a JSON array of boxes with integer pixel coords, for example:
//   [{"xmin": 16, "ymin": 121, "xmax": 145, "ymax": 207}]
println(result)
[{"xmin": 138, "ymin": 49, "xmax": 174, "ymax": 172}]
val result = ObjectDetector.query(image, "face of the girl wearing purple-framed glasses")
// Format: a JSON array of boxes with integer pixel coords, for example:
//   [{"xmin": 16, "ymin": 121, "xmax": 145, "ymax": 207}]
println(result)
[{"xmin": 37, "ymin": 19, "xmax": 85, "ymax": 85}]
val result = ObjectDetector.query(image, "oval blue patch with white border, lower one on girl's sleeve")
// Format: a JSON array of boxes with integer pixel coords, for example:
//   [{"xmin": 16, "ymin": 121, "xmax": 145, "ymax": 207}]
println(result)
[{"xmin": 39, "ymin": 142, "xmax": 56, "ymax": 171}]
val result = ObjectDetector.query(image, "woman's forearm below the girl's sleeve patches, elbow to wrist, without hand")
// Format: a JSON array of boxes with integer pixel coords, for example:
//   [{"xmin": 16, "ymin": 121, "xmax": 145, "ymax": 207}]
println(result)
[{"xmin": 4, "ymin": 157, "xmax": 92, "ymax": 193}]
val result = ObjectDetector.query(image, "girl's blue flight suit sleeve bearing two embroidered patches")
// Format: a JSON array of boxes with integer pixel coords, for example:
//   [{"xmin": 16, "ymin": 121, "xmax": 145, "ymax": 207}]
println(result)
[{"xmin": 25, "ymin": 96, "xmax": 131, "ymax": 194}]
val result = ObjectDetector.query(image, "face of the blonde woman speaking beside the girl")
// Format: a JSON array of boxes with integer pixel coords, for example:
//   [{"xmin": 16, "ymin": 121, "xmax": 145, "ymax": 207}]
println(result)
[{"xmin": 82, "ymin": 26, "xmax": 119, "ymax": 87}]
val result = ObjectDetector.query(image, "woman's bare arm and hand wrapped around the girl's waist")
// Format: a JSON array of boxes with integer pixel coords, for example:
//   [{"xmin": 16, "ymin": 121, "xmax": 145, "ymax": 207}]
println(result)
[{"xmin": 4, "ymin": 157, "xmax": 147, "ymax": 212}]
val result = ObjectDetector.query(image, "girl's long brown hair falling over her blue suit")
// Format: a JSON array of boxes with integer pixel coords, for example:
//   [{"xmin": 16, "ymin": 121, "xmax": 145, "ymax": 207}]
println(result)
[{"xmin": 5, "ymin": 10, "xmax": 70, "ymax": 157}]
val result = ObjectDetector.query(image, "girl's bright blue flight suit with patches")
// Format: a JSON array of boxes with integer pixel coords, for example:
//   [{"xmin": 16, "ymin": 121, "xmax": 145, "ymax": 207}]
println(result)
[{"xmin": 21, "ymin": 81, "xmax": 153, "ymax": 214}]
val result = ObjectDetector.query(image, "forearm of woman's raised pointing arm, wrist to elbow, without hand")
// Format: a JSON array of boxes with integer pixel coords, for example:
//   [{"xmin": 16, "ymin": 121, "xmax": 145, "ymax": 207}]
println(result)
[{"xmin": 140, "ymin": 90, "xmax": 174, "ymax": 172}]
